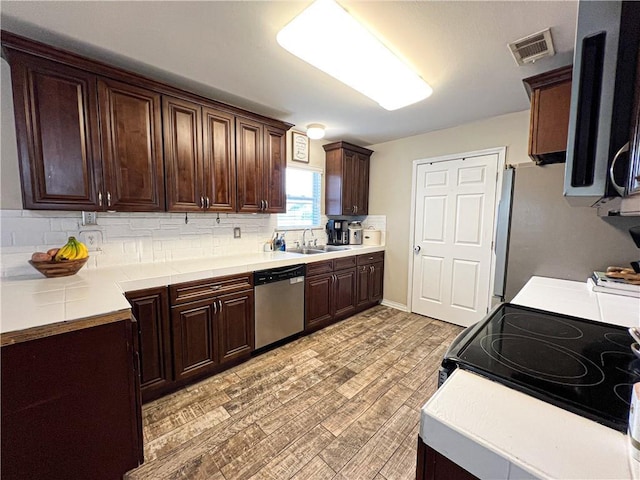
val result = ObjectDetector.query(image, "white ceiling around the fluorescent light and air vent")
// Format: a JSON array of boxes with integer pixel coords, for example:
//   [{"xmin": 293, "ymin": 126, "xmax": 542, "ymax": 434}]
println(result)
[{"xmin": 0, "ymin": 0, "xmax": 577, "ymax": 145}]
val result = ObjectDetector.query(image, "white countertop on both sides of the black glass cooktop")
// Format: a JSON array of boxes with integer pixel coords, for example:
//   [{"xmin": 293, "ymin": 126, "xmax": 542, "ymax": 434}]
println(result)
[{"xmin": 420, "ymin": 277, "xmax": 640, "ymax": 479}]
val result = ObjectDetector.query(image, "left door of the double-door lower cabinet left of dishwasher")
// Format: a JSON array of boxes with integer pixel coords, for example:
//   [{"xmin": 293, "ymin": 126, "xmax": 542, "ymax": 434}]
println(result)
[{"xmin": 171, "ymin": 300, "xmax": 219, "ymax": 380}]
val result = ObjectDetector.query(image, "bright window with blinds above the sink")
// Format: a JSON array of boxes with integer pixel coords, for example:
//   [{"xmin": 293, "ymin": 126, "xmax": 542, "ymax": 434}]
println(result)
[{"xmin": 278, "ymin": 167, "xmax": 322, "ymax": 228}]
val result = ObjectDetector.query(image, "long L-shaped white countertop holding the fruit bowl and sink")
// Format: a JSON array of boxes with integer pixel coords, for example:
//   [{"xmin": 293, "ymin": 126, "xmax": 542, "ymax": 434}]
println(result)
[{"xmin": 0, "ymin": 245, "xmax": 384, "ymax": 334}]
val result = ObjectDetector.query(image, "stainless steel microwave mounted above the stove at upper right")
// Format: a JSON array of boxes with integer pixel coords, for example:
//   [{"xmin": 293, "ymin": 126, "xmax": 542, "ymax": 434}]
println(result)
[{"xmin": 564, "ymin": 1, "xmax": 640, "ymax": 207}]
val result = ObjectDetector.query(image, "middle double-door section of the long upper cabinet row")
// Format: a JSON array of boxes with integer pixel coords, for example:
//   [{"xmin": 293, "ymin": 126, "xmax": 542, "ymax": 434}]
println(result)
[{"xmin": 162, "ymin": 96, "xmax": 236, "ymax": 212}]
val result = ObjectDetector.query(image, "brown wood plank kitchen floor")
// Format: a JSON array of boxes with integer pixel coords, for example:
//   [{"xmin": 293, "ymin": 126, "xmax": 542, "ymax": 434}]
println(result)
[{"xmin": 125, "ymin": 306, "xmax": 461, "ymax": 480}]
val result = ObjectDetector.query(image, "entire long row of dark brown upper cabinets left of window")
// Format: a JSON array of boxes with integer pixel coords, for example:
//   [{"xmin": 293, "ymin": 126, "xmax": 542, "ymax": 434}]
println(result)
[{"xmin": 2, "ymin": 31, "xmax": 291, "ymax": 213}]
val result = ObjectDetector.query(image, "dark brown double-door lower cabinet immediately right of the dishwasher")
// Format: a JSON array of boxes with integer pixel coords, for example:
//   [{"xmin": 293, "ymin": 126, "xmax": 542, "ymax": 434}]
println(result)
[{"xmin": 305, "ymin": 256, "xmax": 356, "ymax": 332}]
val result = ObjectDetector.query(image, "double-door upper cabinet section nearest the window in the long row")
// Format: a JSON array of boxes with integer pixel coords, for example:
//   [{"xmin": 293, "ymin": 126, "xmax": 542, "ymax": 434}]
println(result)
[{"xmin": 236, "ymin": 118, "xmax": 287, "ymax": 213}]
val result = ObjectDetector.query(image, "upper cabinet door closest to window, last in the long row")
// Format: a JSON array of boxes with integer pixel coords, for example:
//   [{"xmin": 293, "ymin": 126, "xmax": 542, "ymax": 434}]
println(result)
[{"xmin": 264, "ymin": 126, "xmax": 287, "ymax": 213}]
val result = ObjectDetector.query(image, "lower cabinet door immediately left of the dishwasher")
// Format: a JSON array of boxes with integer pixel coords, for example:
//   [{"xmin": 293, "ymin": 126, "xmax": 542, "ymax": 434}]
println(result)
[{"xmin": 217, "ymin": 290, "xmax": 254, "ymax": 363}]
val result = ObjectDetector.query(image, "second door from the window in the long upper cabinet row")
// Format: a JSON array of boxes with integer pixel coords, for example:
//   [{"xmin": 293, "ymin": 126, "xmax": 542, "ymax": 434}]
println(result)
[{"xmin": 236, "ymin": 118, "xmax": 265, "ymax": 213}]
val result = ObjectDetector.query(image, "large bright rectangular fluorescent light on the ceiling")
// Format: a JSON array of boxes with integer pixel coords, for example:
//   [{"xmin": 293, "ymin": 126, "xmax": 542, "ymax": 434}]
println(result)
[{"xmin": 277, "ymin": 0, "xmax": 433, "ymax": 110}]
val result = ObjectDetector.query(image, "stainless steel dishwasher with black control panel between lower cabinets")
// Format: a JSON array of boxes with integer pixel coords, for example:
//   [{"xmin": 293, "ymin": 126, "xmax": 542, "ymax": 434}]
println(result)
[{"xmin": 253, "ymin": 264, "xmax": 306, "ymax": 349}]
